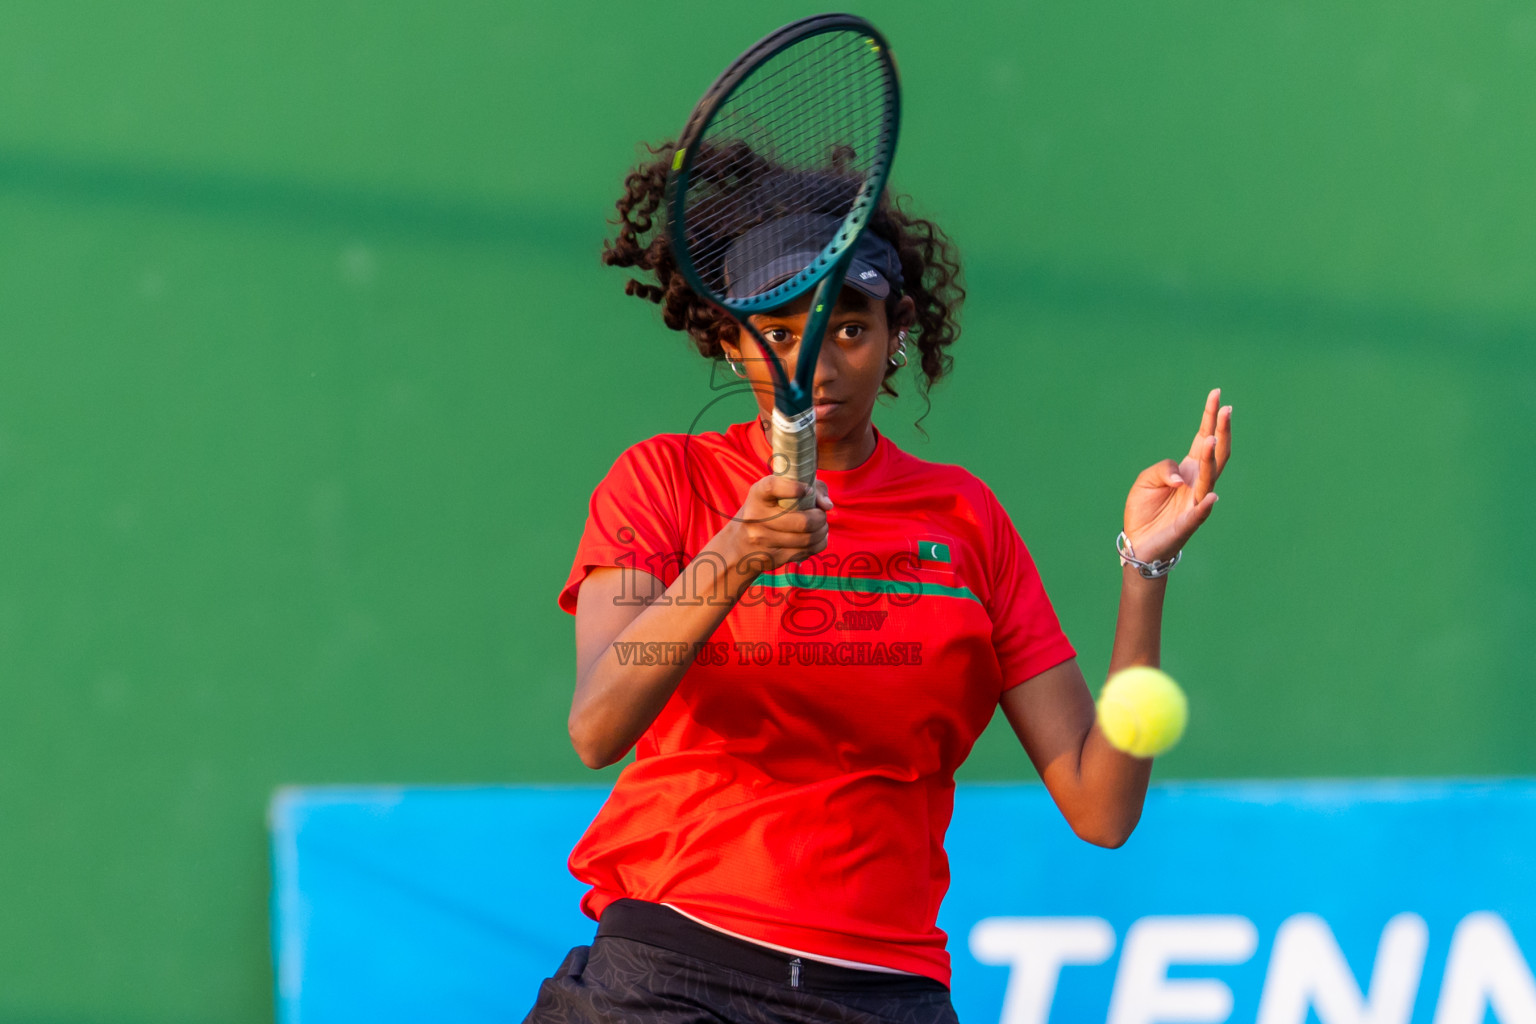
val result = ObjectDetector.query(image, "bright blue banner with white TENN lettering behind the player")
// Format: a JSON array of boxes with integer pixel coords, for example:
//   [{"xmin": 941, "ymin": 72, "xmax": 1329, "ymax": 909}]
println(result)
[{"xmin": 272, "ymin": 780, "xmax": 1536, "ymax": 1024}]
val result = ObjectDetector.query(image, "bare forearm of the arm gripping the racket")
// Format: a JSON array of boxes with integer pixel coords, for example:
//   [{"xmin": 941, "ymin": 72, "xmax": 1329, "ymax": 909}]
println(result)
[{"xmin": 568, "ymin": 550, "xmax": 762, "ymax": 768}]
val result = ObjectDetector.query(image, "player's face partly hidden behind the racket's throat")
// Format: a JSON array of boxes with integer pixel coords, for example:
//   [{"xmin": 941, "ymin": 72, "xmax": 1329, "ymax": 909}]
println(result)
[{"xmin": 725, "ymin": 289, "xmax": 915, "ymax": 445}]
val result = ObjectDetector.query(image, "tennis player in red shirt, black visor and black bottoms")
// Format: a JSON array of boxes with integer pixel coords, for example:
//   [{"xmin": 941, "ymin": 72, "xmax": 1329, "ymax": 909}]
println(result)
[{"xmin": 528, "ymin": 149, "xmax": 1232, "ymax": 1024}]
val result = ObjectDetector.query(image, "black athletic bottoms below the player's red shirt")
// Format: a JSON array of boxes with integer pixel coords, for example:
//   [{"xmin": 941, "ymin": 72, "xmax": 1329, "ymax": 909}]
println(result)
[{"xmin": 524, "ymin": 900, "xmax": 958, "ymax": 1024}]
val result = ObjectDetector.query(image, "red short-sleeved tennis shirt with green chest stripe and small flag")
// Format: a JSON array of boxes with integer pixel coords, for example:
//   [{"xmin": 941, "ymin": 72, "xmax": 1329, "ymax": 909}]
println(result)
[{"xmin": 559, "ymin": 422, "xmax": 1077, "ymax": 984}]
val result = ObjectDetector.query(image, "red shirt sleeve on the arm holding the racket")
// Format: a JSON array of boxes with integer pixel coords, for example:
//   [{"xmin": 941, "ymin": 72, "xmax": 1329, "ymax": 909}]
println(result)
[{"xmin": 559, "ymin": 438, "xmax": 684, "ymax": 614}]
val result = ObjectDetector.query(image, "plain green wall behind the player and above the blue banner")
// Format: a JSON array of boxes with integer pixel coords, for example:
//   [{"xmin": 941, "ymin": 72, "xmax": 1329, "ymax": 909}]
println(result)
[{"xmin": 0, "ymin": 0, "xmax": 1536, "ymax": 1024}]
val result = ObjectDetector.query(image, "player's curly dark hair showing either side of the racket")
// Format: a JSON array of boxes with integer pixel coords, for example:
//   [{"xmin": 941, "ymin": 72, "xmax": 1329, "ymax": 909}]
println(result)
[{"xmin": 602, "ymin": 141, "xmax": 965, "ymax": 398}]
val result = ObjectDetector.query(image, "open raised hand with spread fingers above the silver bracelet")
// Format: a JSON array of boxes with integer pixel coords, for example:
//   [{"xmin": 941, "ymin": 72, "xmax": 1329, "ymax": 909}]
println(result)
[{"xmin": 1126, "ymin": 388, "xmax": 1232, "ymax": 562}]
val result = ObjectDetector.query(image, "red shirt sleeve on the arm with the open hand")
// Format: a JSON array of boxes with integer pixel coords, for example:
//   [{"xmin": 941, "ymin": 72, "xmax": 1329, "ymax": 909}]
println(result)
[{"xmin": 986, "ymin": 490, "xmax": 1077, "ymax": 689}]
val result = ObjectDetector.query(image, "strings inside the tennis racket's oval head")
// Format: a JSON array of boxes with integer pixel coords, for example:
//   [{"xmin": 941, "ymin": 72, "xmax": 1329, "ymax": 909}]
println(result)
[{"xmin": 682, "ymin": 31, "xmax": 895, "ymax": 298}]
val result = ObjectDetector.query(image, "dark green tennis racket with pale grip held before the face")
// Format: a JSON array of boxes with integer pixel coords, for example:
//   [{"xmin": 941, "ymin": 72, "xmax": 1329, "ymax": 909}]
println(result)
[{"xmin": 667, "ymin": 14, "xmax": 902, "ymax": 508}]
